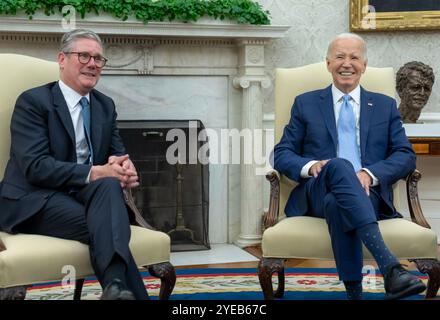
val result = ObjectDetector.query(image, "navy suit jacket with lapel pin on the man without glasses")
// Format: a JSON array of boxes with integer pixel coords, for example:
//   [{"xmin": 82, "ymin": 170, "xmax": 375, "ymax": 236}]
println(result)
[{"xmin": 274, "ymin": 86, "xmax": 416, "ymax": 216}]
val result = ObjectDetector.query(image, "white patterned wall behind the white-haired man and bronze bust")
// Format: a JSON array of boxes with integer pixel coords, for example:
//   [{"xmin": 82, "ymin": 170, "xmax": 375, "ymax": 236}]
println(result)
[{"xmin": 257, "ymin": 0, "xmax": 440, "ymax": 113}]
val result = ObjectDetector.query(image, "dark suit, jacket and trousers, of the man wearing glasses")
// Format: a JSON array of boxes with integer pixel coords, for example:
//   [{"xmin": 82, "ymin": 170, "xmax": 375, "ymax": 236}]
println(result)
[{"xmin": 0, "ymin": 82, "xmax": 147, "ymax": 299}]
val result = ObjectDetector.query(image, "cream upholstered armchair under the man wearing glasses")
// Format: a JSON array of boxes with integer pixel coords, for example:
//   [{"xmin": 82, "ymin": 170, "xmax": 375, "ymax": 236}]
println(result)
[{"xmin": 0, "ymin": 54, "xmax": 176, "ymax": 300}]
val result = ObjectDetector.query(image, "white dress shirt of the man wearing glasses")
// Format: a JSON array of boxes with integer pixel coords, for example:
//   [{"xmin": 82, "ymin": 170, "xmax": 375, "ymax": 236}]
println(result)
[{"xmin": 58, "ymin": 80, "xmax": 91, "ymax": 183}]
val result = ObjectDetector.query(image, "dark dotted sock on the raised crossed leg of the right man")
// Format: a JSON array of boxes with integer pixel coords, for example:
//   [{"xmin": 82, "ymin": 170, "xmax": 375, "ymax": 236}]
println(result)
[{"xmin": 356, "ymin": 223, "xmax": 399, "ymax": 275}]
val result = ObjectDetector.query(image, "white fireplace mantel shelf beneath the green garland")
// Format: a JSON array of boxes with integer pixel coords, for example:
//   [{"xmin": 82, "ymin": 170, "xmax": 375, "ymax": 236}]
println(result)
[{"xmin": 0, "ymin": 14, "xmax": 290, "ymax": 40}]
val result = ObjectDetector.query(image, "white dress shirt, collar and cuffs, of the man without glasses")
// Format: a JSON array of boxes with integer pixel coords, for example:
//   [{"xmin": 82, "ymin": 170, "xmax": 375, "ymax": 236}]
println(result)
[{"xmin": 301, "ymin": 84, "xmax": 379, "ymax": 186}]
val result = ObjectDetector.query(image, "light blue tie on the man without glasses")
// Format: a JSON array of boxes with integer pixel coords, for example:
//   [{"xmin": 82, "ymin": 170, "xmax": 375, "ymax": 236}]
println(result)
[{"xmin": 338, "ymin": 94, "xmax": 362, "ymax": 172}]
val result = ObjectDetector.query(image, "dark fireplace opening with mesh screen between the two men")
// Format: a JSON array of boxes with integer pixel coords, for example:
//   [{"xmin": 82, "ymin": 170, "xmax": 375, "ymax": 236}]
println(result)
[{"xmin": 118, "ymin": 120, "xmax": 210, "ymax": 252}]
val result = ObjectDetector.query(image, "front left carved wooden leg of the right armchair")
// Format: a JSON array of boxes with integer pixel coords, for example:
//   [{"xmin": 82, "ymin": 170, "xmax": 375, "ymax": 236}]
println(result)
[{"xmin": 258, "ymin": 258, "xmax": 285, "ymax": 300}]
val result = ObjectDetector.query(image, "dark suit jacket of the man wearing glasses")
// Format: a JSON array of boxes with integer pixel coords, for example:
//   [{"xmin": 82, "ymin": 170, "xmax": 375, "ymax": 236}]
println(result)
[{"xmin": 0, "ymin": 82, "xmax": 125, "ymax": 232}]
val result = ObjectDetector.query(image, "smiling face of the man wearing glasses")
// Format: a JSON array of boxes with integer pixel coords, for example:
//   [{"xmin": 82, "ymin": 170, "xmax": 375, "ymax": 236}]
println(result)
[{"xmin": 58, "ymin": 38, "xmax": 103, "ymax": 96}]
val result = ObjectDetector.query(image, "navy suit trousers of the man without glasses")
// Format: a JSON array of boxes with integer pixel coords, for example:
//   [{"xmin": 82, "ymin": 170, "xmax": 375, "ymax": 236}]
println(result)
[{"xmin": 306, "ymin": 158, "xmax": 386, "ymax": 281}]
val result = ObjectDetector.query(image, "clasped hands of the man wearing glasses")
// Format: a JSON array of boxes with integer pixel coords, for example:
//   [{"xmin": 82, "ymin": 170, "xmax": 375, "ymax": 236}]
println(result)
[{"xmin": 90, "ymin": 154, "xmax": 139, "ymax": 188}]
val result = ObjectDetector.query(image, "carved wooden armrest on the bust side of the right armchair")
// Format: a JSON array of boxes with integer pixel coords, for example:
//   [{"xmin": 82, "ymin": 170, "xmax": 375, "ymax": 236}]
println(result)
[{"xmin": 406, "ymin": 170, "xmax": 431, "ymax": 229}]
